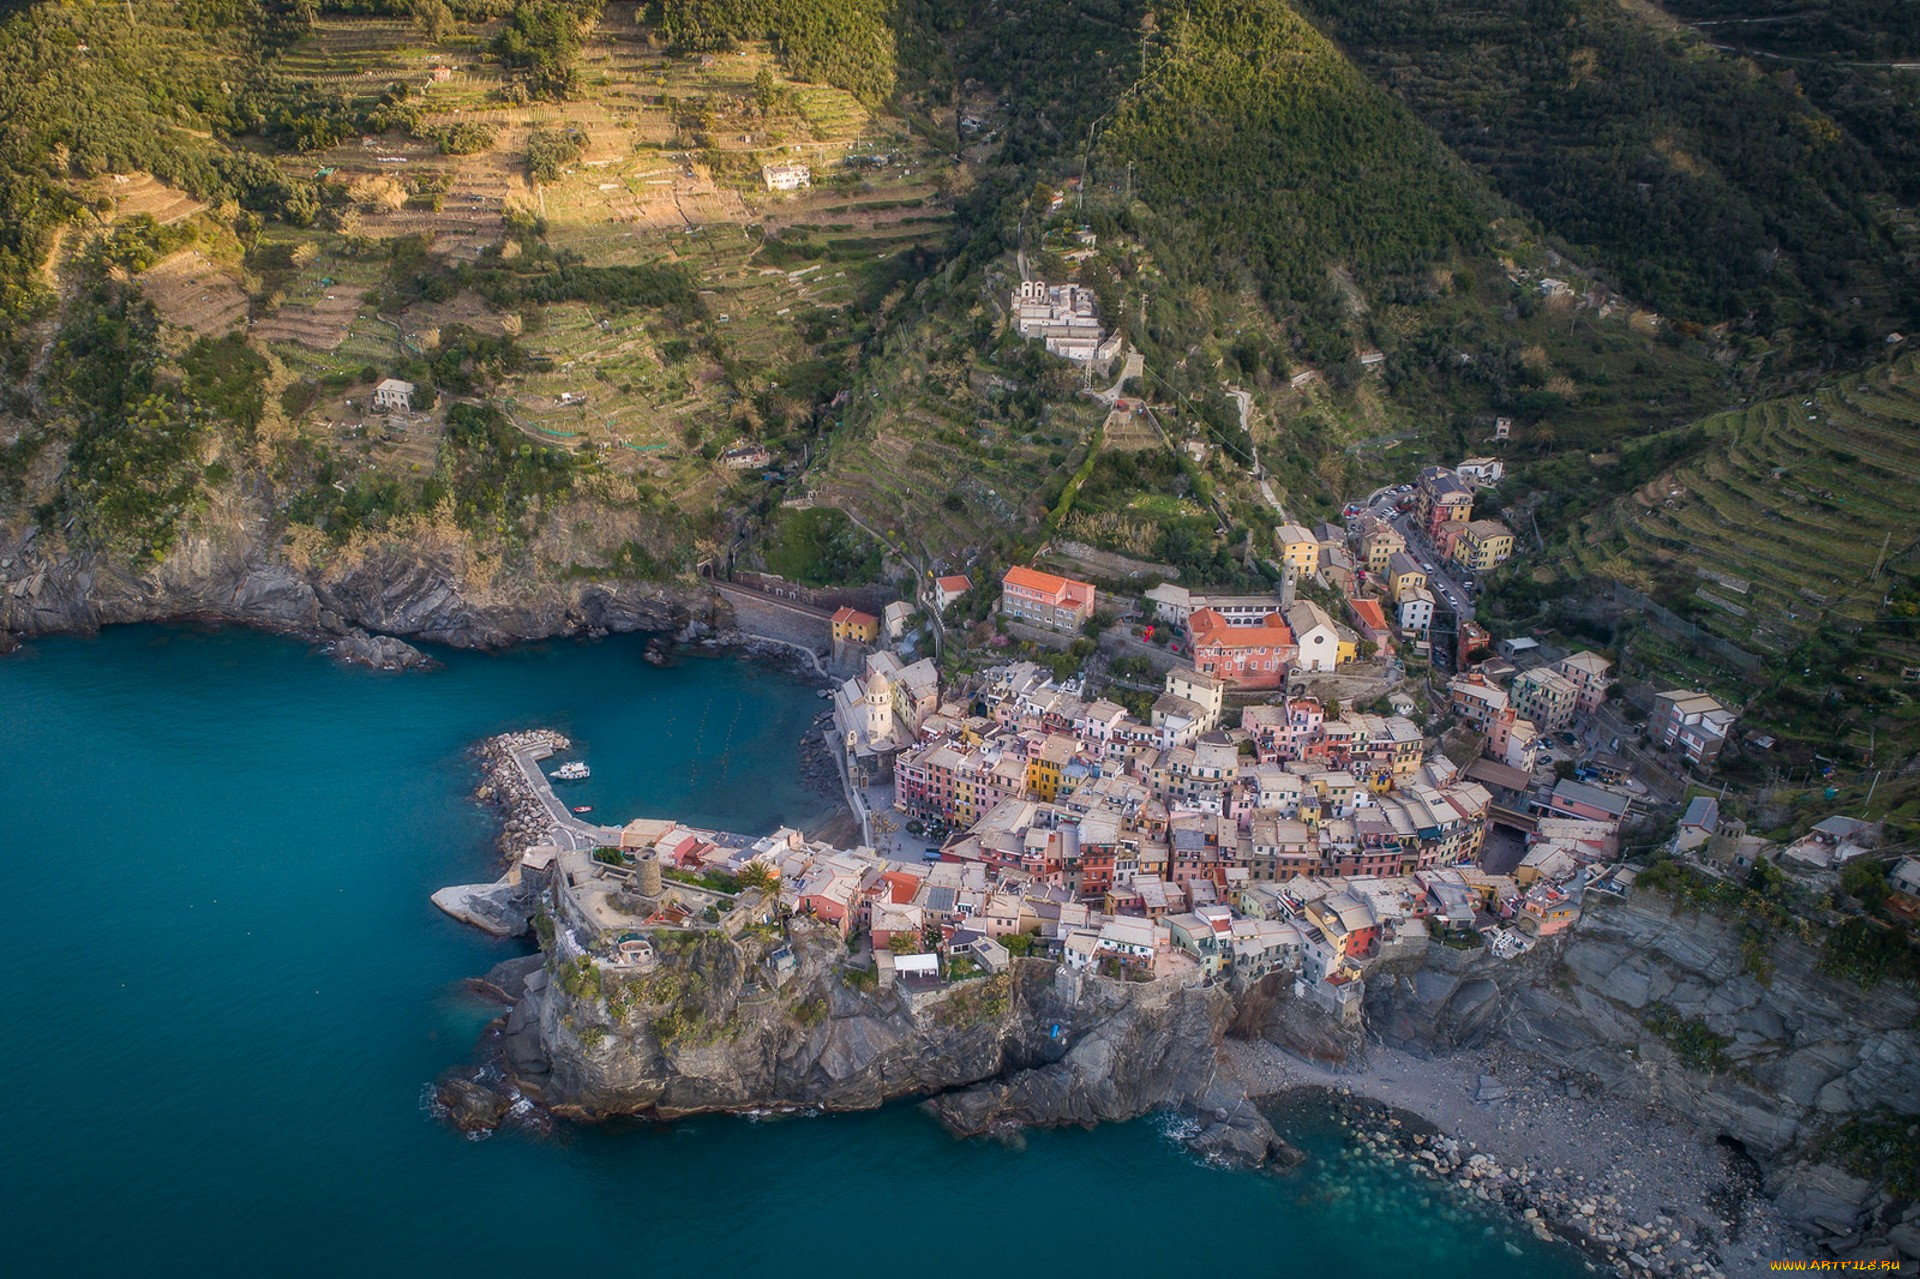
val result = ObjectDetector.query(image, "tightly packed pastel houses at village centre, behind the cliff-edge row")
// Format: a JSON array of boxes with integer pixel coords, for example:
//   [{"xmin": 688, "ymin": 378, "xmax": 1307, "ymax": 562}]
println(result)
[{"xmin": 893, "ymin": 663, "xmax": 1619, "ymax": 897}]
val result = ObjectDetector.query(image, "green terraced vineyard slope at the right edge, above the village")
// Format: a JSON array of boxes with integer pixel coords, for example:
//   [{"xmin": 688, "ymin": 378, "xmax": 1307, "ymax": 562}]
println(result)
[{"xmin": 1571, "ymin": 355, "xmax": 1920, "ymax": 684}]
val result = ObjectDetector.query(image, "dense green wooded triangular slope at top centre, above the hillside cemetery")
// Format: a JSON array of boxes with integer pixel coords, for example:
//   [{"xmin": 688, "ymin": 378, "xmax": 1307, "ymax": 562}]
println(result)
[{"xmin": 1102, "ymin": 0, "xmax": 1496, "ymax": 363}]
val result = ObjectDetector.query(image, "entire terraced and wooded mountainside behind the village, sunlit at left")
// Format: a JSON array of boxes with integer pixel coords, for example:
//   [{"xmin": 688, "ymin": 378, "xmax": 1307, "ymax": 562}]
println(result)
[{"xmin": 0, "ymin": 0, "xmax": 1920, "ymax": 652}]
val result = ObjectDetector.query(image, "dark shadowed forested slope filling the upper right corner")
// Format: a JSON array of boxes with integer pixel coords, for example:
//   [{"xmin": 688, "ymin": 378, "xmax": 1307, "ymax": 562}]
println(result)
[{"xmin": 1304, "ymin": 0, "xmax": 1914, "ymax": 353}]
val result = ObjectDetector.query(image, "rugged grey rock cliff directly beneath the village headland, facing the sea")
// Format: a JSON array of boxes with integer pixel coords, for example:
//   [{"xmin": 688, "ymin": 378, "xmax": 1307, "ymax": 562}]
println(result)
[{"xmin": 505, "ymin": 917, "xmax": 1290, "ymax": 1164}]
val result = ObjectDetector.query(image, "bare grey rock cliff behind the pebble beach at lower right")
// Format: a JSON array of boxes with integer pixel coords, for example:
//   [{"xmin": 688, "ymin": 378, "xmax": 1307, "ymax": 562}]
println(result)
[{"xmin": 1367, "ymin": 893, "xmax": 1920, "ymax": 1237}]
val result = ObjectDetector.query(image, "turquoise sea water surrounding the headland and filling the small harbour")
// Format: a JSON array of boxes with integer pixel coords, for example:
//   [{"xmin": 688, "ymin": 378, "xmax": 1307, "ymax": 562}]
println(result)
[{"xmin": 0, "ymin": 628, "xmax": 1584, "ymax": 1279}]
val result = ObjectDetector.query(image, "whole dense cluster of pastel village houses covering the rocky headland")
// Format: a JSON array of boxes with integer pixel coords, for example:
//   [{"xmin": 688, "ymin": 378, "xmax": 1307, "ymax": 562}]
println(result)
[{"xmin": 522, "ymin": 626, "xmax": 1651, "ymax": 1016}]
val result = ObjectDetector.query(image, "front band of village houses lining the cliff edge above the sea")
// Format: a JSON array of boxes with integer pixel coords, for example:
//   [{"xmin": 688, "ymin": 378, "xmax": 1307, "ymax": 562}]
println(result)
[{"xmin": 537, "ymin": 760, "xmax": 1603, "ymax": 1014}]
